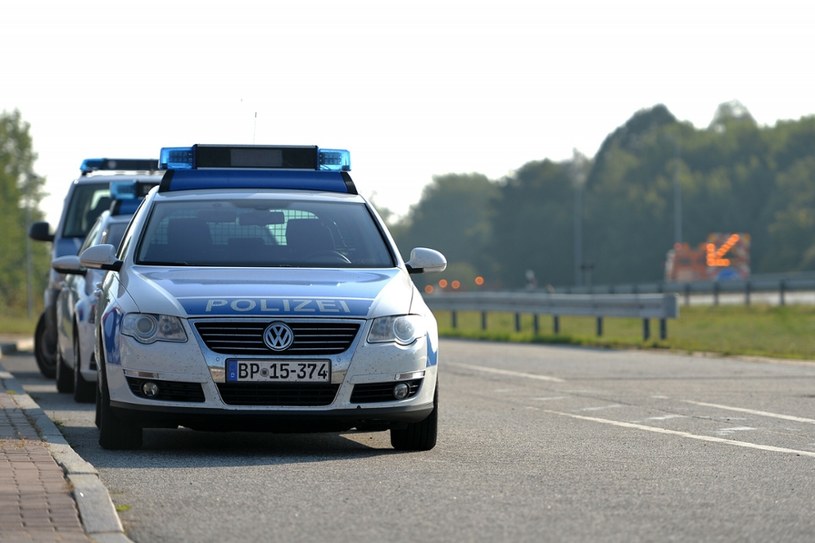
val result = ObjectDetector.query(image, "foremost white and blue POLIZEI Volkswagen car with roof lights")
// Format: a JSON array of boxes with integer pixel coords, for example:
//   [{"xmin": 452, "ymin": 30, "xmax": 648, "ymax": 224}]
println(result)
[{"xmin": 80, "ymin": 145, "xmax": 447, "ymax": 450}]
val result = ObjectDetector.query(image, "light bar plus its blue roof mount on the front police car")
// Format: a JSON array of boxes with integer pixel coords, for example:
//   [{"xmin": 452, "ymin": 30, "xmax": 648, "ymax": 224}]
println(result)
[{"xmin": 159, "ymin": 144, "xmax": 357, "ymax": 194}]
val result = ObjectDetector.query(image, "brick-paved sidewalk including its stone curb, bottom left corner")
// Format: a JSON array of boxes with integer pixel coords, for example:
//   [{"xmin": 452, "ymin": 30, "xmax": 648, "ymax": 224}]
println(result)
[{"xmin": 0, "ymin": 337, "xmax": 130, "ymax": 543}]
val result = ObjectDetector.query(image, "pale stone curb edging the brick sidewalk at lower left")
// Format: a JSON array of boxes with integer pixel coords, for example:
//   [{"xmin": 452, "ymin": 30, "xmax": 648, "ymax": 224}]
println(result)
[{"xmin": 0, "ymin": 344, "xmax": 133, "ymax": 543}]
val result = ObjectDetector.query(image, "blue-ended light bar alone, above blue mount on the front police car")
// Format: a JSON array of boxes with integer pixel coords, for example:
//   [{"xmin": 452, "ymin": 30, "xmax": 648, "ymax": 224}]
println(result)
[{"xmin": 159, "ymin": 144, "xmax": 351, "ymax": 172}]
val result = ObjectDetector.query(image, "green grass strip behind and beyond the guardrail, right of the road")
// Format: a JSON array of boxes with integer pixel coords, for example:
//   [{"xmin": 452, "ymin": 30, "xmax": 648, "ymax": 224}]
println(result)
[{"xmin": 436, "ymin": 305, "xmax": 815, "ymax": 361}]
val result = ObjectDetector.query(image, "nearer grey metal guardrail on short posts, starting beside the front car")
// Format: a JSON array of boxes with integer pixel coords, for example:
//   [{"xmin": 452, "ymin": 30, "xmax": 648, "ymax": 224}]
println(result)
[{"xmin": 425, "ymin": 291, "xmax": 679, "ymax": 340}]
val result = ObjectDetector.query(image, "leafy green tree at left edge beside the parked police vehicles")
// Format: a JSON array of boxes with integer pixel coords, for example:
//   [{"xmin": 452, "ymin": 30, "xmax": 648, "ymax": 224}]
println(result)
[{"xmin": 0, "ymin": 111, "xmax": 48, "ymax": 310}]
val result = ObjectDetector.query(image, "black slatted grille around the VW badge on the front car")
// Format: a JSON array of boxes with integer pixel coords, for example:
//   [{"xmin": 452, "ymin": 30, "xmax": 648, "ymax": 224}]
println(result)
[{"xmin": 195, "ymin": 321, "xmax": 360, "ymax": 356}]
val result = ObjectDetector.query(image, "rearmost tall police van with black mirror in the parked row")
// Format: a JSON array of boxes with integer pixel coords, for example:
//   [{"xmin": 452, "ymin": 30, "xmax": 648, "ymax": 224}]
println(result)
[{"xmin": 28, "ymin": 158, "xmax": 161, "ymax": 378}]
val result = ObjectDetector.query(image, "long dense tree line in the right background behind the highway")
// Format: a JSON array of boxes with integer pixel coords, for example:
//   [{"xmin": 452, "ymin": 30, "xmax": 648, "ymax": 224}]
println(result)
[{"xmin": 392, "ymin": 102, "xmax": 815, "ymax": 288}]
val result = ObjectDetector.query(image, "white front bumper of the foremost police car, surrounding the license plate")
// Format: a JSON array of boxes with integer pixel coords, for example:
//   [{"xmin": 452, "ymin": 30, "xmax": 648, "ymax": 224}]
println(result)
[{"xmin": 104, "ymin": 314, "xmax": 438, "ymax": 432}]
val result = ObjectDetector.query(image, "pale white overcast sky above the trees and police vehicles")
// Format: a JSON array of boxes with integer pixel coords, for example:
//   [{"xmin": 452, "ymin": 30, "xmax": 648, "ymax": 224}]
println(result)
[{"xmin": 0, "ymin": 0, "xmax": 815, "ymax": 224}]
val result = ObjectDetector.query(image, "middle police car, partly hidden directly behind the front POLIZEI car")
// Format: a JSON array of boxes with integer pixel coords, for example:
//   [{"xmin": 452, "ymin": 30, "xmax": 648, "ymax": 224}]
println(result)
[{"xmin": 51, "ymin": 181, "xmax": 157, "ymax": 402}]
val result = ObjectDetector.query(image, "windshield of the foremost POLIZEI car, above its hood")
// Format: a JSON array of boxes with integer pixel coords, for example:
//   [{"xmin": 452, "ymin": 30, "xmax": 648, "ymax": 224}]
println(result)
[{"xmin": 135, "ymin": 199, "xmax": 396, "ymax": 268}]
